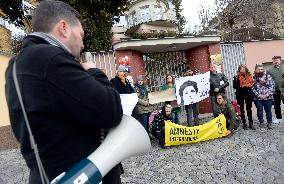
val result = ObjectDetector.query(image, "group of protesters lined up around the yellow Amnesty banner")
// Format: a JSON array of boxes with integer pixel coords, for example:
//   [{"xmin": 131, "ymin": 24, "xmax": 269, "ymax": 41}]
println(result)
[{"xmin": 112, "ymin": 56, "xmax": 284, "ymax": 147}]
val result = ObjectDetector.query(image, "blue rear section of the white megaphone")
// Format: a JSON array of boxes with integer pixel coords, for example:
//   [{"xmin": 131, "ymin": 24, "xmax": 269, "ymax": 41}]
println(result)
[{"xmin": 55, "ymin": 159, "xmax": 102, "ymax": 184}]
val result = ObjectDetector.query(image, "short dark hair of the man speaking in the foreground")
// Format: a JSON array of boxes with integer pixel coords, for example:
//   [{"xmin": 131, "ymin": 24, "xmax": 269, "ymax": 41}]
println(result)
[{"xmin": 32, "ymin": 0, "xmax": 83, "ymax": 33}]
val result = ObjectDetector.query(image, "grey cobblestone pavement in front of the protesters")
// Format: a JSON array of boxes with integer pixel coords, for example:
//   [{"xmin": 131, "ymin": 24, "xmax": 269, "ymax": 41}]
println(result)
[{"xmin": 0, "ymin": 108, "xmax": 284, "ymax": 184}]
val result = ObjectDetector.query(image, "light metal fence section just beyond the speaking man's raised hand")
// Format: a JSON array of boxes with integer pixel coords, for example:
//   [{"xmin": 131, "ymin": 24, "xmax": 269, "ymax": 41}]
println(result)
[{"xmin": 83, "ymin": 51, "xmax": 116, "ymax": 79}]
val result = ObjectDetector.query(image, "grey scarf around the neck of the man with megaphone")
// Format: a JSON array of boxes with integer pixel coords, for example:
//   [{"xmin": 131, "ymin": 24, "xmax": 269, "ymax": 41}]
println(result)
[{"xmin": 30, "ymin": 32, "xmax": 73, "ymax": 55}]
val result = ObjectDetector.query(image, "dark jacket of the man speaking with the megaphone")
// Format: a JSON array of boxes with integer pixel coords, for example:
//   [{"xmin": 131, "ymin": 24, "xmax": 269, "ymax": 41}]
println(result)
[{"xmin": 6, "ymin": 36, "xmax": 122, "ymax": 183}]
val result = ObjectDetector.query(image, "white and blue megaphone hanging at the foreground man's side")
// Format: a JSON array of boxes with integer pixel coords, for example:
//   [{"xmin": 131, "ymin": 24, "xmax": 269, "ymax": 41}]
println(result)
[{"xmin": 51, "ymin": 115, "xmax": 151, "ymax": 184}]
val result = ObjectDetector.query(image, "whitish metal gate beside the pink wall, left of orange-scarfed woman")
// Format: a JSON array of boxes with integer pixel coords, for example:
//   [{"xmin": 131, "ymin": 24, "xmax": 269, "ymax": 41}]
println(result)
[{"xmin": 221, "ymin": 43, "xmax": 245, "ymax": 100}]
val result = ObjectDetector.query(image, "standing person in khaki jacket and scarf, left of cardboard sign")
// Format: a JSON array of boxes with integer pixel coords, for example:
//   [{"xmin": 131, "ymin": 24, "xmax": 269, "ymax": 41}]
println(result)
[{"xmin": 134, "ymin": 75, "xmax": 153, "ymax": 132}]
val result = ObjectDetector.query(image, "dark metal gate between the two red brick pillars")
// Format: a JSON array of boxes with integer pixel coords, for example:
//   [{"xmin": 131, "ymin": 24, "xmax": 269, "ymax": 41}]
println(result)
[{"xmin": 143, "ymin": 51, "xmax": 187, "ymax": 91}]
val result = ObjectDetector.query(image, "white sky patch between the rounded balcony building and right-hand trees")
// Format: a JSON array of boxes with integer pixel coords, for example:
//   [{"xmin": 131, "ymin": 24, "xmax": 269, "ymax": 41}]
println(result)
[{"xmin": 182, "ymin": 0, "xmax": 215, "ymax": 29}]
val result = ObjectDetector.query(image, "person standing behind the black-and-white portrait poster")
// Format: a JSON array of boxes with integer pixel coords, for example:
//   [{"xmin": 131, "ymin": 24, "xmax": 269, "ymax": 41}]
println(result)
[{"xmin": 185, "ymin": 67, "xmax": 199, "ymax": 126}]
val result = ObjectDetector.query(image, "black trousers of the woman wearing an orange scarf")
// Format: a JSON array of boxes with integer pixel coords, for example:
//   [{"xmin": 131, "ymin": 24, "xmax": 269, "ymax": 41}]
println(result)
[{"xmin": 237, "ymin": 96, "xmax": 253, "ymax": 124}]
